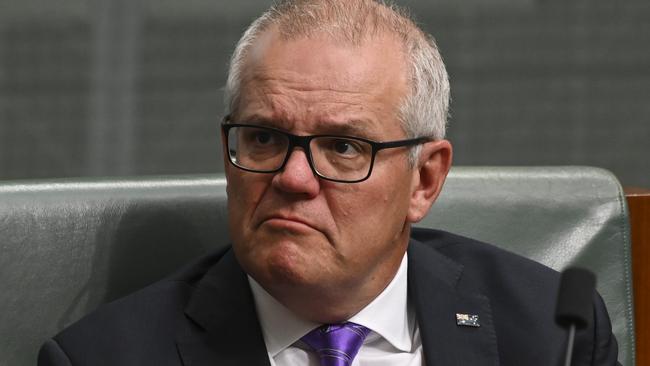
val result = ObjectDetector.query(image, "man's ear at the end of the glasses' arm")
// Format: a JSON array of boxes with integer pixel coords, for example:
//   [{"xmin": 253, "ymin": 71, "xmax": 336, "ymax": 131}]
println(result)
[{"xmin": 406, "ymin": 140, "xmax": 452, "ymax": 223}]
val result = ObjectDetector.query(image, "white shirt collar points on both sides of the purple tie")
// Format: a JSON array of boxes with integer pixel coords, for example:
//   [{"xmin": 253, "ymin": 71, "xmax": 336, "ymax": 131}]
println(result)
[{"xmin": 248, "ymin": 253, "xmax": 415, "ymax": 357}]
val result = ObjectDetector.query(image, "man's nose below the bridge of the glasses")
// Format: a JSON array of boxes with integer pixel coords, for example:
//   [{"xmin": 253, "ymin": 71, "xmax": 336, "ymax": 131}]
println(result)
[{"xmin": 272, "ymin": 148, "xmax": 320, "ymax": 198}]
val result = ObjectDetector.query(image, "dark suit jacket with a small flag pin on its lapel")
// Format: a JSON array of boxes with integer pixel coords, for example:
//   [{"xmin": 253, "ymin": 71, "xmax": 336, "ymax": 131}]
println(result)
[{"xmin": 39, "ymin": 229, "xmax": 617, "ymax": 366}]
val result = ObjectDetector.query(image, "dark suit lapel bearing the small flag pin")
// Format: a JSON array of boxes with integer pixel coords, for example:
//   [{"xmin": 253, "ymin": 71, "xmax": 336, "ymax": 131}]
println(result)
[{"xmin": 408, "ymin": 240, "xmax": 499, "ymax": 366}]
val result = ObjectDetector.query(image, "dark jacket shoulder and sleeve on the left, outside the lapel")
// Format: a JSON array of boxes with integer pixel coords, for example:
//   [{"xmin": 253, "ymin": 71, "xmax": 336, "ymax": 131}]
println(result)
[{"xmin": 41, "ymin": 247, "xmax": 229, "ymax": 365}]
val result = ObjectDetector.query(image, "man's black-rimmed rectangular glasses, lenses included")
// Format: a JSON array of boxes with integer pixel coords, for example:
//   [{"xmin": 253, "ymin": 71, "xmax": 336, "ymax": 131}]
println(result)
[{"xmin": 221, "ymin": 123, "xmax": 432, "ymax": 183}]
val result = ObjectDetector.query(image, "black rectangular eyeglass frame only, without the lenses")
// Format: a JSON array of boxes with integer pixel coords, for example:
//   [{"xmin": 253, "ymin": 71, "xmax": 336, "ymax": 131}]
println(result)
[{"xmin": 221, "ymin": 121, "xmax": 434, "ymax": 183}]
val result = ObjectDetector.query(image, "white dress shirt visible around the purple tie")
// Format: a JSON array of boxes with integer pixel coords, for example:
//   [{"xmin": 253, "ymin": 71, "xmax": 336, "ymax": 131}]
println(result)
[{"xmin": 248, "ymin": 254, "xmax": 424, "ymax": 366}]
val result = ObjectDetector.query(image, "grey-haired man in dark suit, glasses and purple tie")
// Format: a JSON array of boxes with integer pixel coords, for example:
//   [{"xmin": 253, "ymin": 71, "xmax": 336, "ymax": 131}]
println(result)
[{"xmin": 39, "ymin": 0, "xmax": 617, "ymax": 366}]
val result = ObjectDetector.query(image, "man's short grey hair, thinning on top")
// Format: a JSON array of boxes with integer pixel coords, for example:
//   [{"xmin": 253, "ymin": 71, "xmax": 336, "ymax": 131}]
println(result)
[{"xmin": 224, "ymin": 0, "xmax": 449, "ymax": 165}]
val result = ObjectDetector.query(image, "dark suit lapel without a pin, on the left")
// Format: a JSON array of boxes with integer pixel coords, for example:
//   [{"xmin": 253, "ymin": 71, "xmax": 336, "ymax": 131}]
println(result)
[{"xmin": 176, "ymin": 250, "xmax": 270, "ymax": 366}]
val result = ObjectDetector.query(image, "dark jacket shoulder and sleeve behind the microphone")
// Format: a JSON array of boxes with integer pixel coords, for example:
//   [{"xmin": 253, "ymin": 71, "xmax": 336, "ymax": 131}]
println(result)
[{"xmin": 411, "ymin": 229, "xmax": 618, "ymax": 365}]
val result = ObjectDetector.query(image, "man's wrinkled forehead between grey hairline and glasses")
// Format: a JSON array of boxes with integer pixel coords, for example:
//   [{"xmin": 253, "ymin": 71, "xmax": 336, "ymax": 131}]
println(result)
[{"xmin": 237, "ymin": 31, "xmax": 408, "ymax": 137}]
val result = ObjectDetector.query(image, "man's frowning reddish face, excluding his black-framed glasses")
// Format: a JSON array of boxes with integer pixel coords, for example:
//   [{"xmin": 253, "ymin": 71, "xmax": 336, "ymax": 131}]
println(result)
[{"xmin": 226, "ymin": 32, "xmax": 440, "ymax": 318}]
